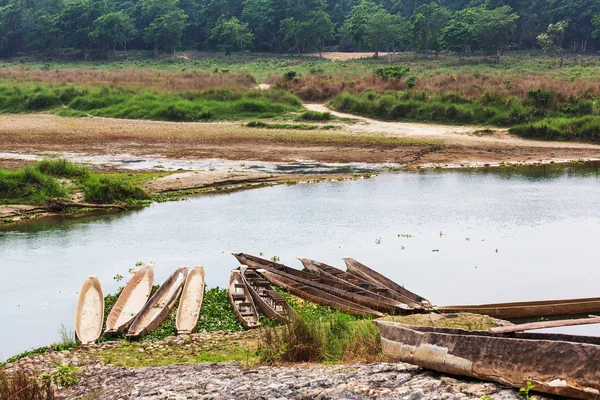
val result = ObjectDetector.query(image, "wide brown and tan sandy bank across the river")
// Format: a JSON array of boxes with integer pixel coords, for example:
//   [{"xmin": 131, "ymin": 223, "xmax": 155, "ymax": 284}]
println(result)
[{"xmin": 0, "ymin": 113, "xmax": 600, "ymax": 168}]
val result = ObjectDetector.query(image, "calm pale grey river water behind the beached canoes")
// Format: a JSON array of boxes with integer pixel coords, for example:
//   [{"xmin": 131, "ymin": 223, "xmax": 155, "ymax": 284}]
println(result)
[{"xmin": 0, "ymin": 165, "xmax": 600, "ymax": 360}]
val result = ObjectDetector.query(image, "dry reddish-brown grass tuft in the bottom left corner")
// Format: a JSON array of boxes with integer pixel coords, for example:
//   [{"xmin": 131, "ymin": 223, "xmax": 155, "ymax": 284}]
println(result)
[{"xmin": 0, "ymin": 368, "xmax": 55, "ymax": 400}]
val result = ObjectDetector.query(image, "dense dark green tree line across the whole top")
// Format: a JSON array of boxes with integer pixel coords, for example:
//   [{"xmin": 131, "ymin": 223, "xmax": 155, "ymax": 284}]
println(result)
[{"xmin": 0, "ymin": 0, "xmax": 600, "ymax": 62}]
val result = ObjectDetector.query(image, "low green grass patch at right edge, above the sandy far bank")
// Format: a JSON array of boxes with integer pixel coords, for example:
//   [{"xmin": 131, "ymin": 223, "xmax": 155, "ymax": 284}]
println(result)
[{"xmin": 510, "ymin": 115, "xmax": 600, "ymax": 143}]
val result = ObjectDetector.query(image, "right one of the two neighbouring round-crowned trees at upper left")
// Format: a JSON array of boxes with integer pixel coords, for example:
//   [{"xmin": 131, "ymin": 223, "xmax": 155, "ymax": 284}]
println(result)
[{"xmin": 144, "ymin": 8, "xmax": 188, "ymax": 61}]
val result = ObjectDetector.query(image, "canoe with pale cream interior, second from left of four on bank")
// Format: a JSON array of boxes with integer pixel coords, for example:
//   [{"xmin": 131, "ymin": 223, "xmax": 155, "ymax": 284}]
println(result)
[{"xmin": 104, "ymin": 265, "xmax": 154, "ymax": 333}]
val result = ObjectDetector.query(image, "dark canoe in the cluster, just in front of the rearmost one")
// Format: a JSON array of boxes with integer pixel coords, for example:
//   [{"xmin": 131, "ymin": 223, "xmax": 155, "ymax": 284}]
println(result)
[{"xmin": 299, "ymin": 258, "xmax": 421, "ymax": 311}]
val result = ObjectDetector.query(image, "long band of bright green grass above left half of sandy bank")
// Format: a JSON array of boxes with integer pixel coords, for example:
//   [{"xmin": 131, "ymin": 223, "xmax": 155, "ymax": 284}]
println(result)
[{"xmin": 0, "ymin": 82, "xmax": 301, "ymax": 122}]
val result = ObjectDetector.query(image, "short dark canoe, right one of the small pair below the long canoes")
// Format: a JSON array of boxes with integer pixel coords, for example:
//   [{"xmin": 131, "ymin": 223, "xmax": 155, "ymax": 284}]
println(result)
[{"xmin": 240, "ymin": 266, "xmax": 296, "ymax": 323}]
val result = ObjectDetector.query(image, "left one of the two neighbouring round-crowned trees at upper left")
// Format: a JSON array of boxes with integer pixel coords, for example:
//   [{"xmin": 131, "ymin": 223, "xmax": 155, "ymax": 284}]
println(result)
[{"xmin": 90, "ymin": 11, "xmax": 136, "ymax": 60}]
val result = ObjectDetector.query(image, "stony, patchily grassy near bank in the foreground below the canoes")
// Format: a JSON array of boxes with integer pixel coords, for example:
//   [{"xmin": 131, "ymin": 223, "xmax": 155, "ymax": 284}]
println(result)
[{"xmin": 0, "ymin": 315, "xmax": 518, "ymax": 400}]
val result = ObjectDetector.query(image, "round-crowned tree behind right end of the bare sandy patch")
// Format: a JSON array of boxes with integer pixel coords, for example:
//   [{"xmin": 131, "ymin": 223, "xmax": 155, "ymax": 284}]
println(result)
[{"xmin": 363, "ymin": 10, "xmax": 408, "ymax": 63}]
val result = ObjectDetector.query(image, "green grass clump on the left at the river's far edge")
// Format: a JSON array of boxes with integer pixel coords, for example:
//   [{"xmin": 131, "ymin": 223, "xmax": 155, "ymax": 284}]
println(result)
[{"xmin": 0, "ymin": 159, "xmax": 151, "ymax": 205}]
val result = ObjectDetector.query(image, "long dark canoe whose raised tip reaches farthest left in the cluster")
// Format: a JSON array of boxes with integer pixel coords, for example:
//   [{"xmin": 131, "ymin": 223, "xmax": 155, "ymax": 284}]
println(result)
[{"xmin": 234, "ymin": 253, "xmax": 412, "ymax": 314}]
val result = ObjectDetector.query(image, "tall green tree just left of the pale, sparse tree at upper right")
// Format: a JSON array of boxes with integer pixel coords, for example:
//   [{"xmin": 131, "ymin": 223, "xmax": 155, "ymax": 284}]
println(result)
[{"xmin": 473, "ymin": 6, "xmax": 519, "ymax": 64}]
